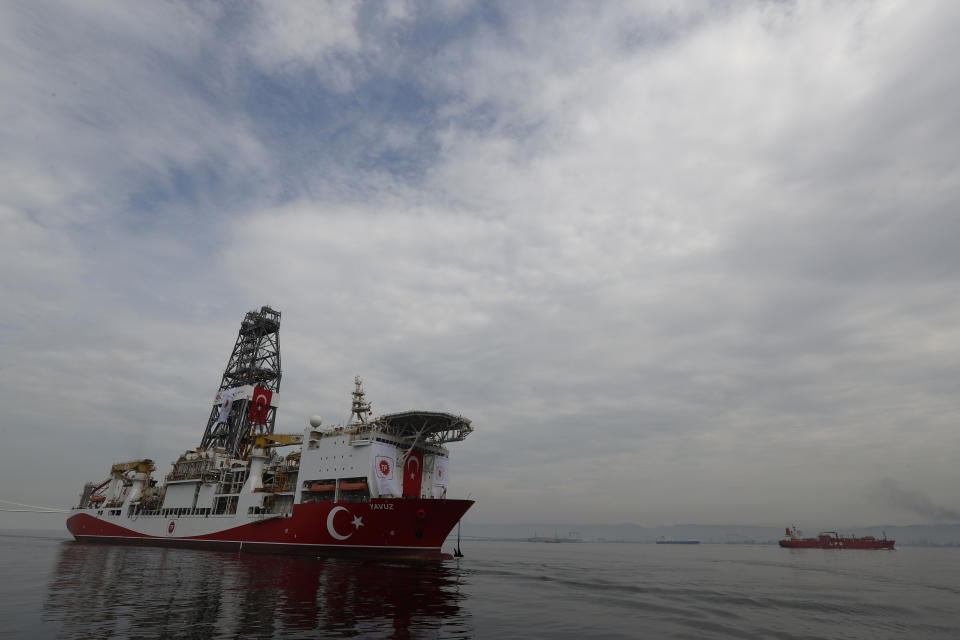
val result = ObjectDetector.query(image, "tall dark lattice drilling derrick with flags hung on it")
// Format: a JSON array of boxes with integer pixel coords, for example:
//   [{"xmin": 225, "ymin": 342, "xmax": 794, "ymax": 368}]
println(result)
[{"xmin": 200, "ymin": 307, "xmax": 281, "ymax": 457}]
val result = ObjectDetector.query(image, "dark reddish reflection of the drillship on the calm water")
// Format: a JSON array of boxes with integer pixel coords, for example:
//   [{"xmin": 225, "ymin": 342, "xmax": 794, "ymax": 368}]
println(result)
[{"xmin": 45, "ymin": 542, "xmax": 473, "ymax": 638}]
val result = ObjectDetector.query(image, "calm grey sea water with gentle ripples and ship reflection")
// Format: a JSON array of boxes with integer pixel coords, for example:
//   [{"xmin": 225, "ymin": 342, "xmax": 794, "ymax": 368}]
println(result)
[{"xmin": 0, "ymin": 532, "xmax": 960, "ymax": 640}]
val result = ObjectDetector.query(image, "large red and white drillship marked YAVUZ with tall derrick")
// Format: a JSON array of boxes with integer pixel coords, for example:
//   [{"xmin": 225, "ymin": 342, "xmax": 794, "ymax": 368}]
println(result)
[{"xmin": 67, "ymin": 306, "xmax": 473, "ymax": 556}]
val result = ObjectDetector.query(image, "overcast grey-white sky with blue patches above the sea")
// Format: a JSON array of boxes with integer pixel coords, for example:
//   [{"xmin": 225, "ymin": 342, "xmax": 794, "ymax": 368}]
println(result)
[{"xmin": 0, "ymin": 0, "xmax": 960, "ymax": 529}]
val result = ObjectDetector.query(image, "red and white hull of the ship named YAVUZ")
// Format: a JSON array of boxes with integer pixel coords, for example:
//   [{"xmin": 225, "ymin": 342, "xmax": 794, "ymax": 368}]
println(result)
[{"xmin": 67, "ymin": 498, "xmax": 473, "ymax": 556}]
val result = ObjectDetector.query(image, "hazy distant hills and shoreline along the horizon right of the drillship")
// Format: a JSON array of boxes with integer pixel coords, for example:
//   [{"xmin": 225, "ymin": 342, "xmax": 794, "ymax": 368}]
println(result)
[{"xmin": 462, "ymin": 521, "xmax": 960, "ymax": 547}]
